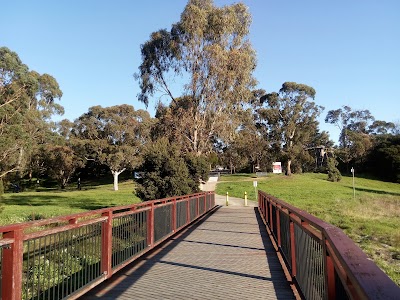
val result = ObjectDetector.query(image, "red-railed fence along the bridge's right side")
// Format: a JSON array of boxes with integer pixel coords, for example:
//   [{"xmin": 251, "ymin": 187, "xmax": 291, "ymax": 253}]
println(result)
[{"xmin": 258, "ymin": 191, "xmax": 400, "ymax": 299}]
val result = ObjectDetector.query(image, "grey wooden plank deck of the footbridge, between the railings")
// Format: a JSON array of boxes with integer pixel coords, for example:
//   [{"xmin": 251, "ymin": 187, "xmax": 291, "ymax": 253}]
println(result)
[{"xmin": 82, "ymin": 207, "xmax": 294, "ymax": 299}]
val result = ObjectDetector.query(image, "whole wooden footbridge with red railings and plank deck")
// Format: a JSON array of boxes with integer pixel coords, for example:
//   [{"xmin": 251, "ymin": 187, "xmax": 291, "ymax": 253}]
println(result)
[{"xmin": 0, "ymin": 191, "xmax": 400, "ymax": 300}]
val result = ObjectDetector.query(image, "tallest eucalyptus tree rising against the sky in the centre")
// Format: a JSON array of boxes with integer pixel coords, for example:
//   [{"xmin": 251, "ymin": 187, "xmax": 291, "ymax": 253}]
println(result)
[{"xmin": 136, "ymin": 0, "xmax": 256, "ymax": 155}]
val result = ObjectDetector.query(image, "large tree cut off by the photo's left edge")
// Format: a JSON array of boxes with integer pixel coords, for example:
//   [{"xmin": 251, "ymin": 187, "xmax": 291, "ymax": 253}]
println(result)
[{"xmin": 0, "ymin": 47, "xmax": 63, "ymax": 177}]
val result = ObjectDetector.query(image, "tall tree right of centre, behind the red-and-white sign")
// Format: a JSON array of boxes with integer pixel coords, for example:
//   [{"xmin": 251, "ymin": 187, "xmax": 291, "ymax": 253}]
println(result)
[{"xmin": 257, "ymin": 82, "xmax": 324, "ymax": 175}]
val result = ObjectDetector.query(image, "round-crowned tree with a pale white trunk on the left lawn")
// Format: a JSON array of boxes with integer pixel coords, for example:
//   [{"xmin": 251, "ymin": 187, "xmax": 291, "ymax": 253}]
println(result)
[{"xmin": 72, "ymin": 104, "xmax": 151, "ymax": 190}]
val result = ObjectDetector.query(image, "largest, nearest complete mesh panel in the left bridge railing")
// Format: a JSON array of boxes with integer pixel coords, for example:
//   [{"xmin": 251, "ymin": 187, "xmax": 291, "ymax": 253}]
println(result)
[{"xmin": 22, "ymin": 223, "xmax": 101, "ymax": 299}]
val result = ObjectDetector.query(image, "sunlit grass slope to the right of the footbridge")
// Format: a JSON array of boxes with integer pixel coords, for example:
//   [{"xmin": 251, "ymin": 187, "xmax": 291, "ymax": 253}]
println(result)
[{"xmin": 216, "ymin": 173, "xmax": 400, "ymax": 285}]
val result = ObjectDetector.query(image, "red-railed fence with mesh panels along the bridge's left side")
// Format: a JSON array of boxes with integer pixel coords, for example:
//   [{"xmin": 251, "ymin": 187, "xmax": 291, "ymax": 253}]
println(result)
[{"xmin": 0, "ymin": 192, "xmax": 215, "ymax": 300}]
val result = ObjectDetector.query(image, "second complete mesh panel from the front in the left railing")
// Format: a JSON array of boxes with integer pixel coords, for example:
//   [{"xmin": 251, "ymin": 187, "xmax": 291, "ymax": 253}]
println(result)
[{"xmin": 111, "ymin": 211, "xmax": 147, "ymax": 268}]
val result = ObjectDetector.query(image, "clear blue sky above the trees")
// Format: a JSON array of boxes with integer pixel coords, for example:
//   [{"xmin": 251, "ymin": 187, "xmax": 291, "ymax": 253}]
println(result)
[{"xmin": 0, "ymin": 0, "xmax": 400, "ymax": 141}]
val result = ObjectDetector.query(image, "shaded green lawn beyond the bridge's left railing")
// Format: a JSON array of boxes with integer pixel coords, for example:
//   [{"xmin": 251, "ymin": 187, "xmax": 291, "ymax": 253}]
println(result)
[{"xmin": 0, "ymin": 180, "xmax": 140, "ymax": 226}]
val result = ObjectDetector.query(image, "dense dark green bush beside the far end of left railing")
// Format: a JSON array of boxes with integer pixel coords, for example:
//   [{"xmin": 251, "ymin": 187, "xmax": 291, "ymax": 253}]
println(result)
[{"xmin": 137, "ymin": 138, "xmax": 199, "ymax": 200}]
